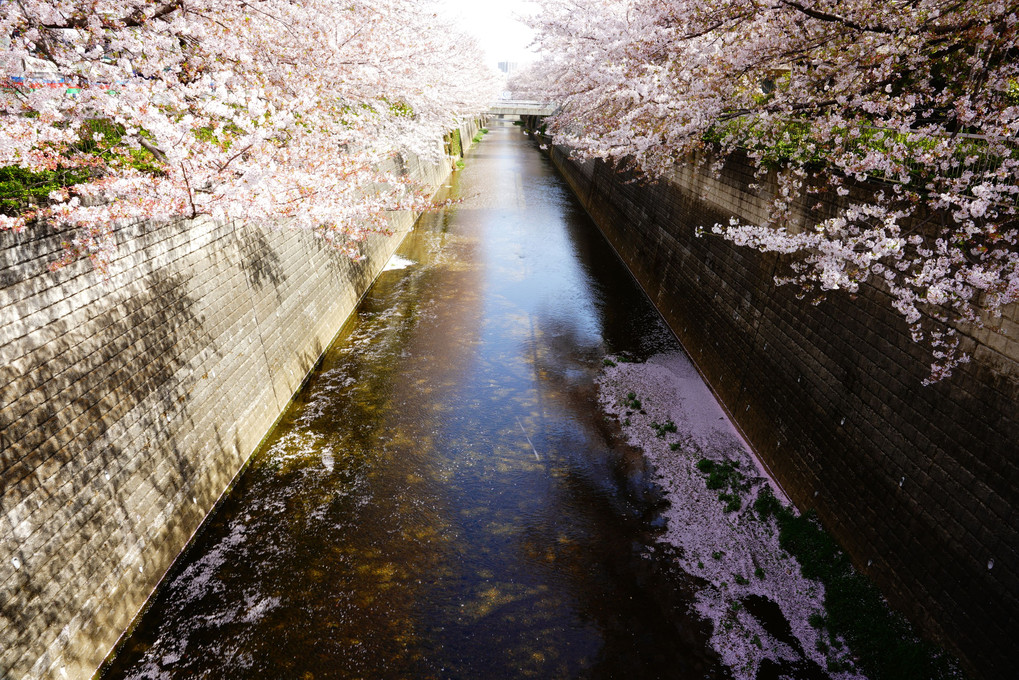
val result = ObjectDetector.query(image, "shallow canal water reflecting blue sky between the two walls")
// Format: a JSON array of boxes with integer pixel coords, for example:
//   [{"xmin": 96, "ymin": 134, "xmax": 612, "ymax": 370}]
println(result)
[{"xmin": 103, "ymin": 121, "xmax": 728, "ymax": 679}]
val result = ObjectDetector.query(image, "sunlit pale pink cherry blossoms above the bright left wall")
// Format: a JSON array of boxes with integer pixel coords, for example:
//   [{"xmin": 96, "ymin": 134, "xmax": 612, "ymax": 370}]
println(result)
[{"xmin": 0, "ymin": 0, "xmax": 497, "ymax": 269}]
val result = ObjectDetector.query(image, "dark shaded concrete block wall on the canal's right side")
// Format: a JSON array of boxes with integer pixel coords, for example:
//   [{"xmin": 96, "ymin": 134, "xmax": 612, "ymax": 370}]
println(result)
[{"xmin": 552, "ymin": 148, "xmax": 1019, "ymax": 679}]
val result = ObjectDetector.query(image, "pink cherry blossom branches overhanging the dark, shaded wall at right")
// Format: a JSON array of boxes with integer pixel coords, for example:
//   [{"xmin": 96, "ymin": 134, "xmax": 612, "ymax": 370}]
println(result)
[{"xmin": 514, "ymin": 0, "xmax": 1019, "ymax": 380}]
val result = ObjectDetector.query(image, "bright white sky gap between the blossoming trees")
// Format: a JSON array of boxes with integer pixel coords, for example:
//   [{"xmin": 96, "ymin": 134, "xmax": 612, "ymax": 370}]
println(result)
[{"xmin": 436, "ymin": 0, "xmax": 536, "ymax": 68}]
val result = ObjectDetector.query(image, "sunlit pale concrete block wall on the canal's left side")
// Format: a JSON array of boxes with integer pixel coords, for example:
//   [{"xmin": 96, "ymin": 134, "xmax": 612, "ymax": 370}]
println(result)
[{"xmin": 0, "ymin": 122, "xmax": 478, "ymax": 680}]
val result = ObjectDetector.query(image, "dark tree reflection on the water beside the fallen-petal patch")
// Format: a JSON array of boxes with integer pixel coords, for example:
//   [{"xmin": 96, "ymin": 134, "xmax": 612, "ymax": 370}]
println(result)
[{"xmin": 505, "ymin": 311, "xmax": 721, "ymax": 677}]
